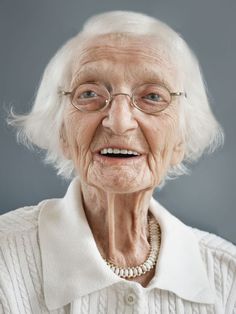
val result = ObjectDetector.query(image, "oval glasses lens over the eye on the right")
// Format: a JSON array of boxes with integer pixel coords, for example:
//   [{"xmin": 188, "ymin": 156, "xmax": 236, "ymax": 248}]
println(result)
[{"xmin": 133, "ymin": 84, "xmax": 171, "ymax": 113}]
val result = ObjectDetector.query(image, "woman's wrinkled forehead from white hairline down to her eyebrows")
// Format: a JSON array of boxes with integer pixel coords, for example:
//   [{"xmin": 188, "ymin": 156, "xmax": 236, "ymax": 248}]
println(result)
[{"xmin": 72, "ymin": 37, "xmax": 177, "ymax": 85}]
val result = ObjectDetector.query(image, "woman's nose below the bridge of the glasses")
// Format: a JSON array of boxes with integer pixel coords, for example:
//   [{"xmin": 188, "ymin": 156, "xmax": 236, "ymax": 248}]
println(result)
[{"xmin": 102, "ymin": 93, "xmax": 138, "ymax": 135}]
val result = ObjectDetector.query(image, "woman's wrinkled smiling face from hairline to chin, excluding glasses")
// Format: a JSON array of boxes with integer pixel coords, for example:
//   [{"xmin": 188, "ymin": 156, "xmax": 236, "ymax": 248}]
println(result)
[{"xmin": 61, "ymin": 34, "xmax": 184, "ymax": 193}]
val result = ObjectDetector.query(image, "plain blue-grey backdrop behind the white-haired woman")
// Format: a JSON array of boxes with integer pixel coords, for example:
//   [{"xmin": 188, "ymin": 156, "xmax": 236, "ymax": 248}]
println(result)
[{"xmin": 0, "ymin": 0, "xmax": 236, "ymax": 243}]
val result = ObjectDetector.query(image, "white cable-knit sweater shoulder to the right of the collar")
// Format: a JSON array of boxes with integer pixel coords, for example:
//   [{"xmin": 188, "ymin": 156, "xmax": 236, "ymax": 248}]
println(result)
[{"xmin": 191, "ymin": 228, "xmax": 236, "ymax": 313}]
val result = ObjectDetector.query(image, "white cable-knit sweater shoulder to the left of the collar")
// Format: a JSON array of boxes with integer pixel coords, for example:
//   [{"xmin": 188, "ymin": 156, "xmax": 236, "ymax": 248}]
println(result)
[{"xmin": 0, "ymin": 201, "xmax": 52, "ymax": 313}]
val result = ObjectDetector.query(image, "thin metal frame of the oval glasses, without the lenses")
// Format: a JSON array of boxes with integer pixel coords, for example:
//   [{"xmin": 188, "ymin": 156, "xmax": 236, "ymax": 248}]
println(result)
[{"xmin": 61, "ymin": 83, "xmax": 187, "ymax": 114}]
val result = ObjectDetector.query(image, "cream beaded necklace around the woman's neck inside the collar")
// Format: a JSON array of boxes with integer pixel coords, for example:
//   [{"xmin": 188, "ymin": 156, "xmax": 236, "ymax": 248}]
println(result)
[{"xmin": 104, "ymin": 218, "xmax": 161, "ymax": 278}]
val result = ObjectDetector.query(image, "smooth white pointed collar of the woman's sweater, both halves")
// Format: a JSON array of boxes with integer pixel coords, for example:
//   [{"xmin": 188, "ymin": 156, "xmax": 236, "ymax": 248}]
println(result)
[{"xmin": 39, "ymin": 178, "xmax": 214, "ymax": 310}]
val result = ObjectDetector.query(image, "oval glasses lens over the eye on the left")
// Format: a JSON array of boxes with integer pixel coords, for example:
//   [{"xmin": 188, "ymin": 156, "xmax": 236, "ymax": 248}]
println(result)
[{"xmin": 72, "ymin": 84, "xmax": 109, "ymax": 111}]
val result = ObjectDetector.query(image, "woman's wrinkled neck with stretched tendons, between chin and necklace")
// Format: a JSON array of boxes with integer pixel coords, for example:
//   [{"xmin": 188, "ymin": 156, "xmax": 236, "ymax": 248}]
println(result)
[{"xmin": 81, "ymin": 183, "xmax": 153, "ymax": 267}]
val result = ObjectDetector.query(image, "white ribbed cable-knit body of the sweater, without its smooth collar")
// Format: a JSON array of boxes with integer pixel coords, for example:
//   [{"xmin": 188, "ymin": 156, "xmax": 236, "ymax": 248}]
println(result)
[{"xmin": 0, "ymin": 206, "xmax": 236, "ymax": 314}]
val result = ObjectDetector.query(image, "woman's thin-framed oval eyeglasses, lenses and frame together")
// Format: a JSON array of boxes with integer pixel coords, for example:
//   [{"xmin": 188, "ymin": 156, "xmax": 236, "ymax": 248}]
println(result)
[{"xmin": 62, "ymin": 83, "xmax": 187, "ymax": 114}]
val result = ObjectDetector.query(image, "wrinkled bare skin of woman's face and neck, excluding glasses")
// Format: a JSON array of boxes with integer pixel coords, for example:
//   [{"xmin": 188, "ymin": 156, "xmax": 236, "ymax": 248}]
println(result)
[{"xmin": 61, "ymin": 34, "xmax": 184, "ymax": 286}]
